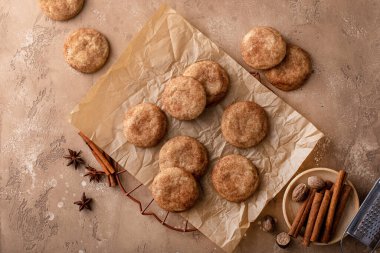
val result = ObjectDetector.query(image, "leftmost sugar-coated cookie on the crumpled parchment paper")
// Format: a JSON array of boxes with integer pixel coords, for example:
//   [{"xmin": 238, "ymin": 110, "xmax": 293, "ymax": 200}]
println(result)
[{"xmin": 124, "ymin": 103, "xmax": 167, "ymax": 148}]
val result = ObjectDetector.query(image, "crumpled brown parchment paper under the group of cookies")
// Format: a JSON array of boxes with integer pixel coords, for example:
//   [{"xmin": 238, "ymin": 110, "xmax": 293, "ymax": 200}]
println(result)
[{"xmin": 70, "ymin": 6, "xmax": 323, "ymax": 252}]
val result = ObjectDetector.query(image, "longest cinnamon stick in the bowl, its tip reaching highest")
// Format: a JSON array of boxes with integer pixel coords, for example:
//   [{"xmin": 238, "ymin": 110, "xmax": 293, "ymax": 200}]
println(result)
[{"xmin": 321, "ymin": 170, "xmax": 346, "ymax": 243}]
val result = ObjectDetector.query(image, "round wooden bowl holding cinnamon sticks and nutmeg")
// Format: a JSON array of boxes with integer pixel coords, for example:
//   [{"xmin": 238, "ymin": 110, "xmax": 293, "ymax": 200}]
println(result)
[{"xmin": 282, "ymin": 168, "xmax": 359, "ymax": 245}]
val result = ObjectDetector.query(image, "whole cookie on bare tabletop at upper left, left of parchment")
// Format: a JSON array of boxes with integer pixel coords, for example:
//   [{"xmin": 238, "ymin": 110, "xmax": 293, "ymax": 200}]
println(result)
[{"xmin": 64, "ymin": 28, "xmax": 109, "ymax": 73}]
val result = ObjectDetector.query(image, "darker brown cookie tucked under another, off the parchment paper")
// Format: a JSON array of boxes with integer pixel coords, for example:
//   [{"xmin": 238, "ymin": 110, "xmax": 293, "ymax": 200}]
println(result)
[{"xmin": 264, "ymin": 45, "xmax": 312, "ymax": 91}]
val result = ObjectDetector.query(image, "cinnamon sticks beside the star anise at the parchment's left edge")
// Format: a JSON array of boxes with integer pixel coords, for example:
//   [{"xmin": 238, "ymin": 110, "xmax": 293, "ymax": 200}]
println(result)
[{"xmin": 78, "ymin": 132, "xmax": 117, "ymax": 187}]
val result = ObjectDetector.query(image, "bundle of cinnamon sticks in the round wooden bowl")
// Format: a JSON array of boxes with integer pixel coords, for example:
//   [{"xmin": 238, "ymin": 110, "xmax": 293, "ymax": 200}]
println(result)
[{"xmin": 288, "ymin": 170, "xmax": 351, "ymax": 246}]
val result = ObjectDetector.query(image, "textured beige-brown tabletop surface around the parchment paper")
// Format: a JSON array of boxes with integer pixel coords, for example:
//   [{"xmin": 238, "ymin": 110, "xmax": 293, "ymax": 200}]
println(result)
[{"xmin": 0, "ymin": 0, "xmax": 380, "ymax": 252}]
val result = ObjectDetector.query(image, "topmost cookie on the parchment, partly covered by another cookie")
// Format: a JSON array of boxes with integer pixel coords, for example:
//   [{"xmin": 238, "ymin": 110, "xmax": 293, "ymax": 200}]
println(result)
[{"xmin": 183, "ymin": 61, "xmax": 229, "ymax": 105}]
